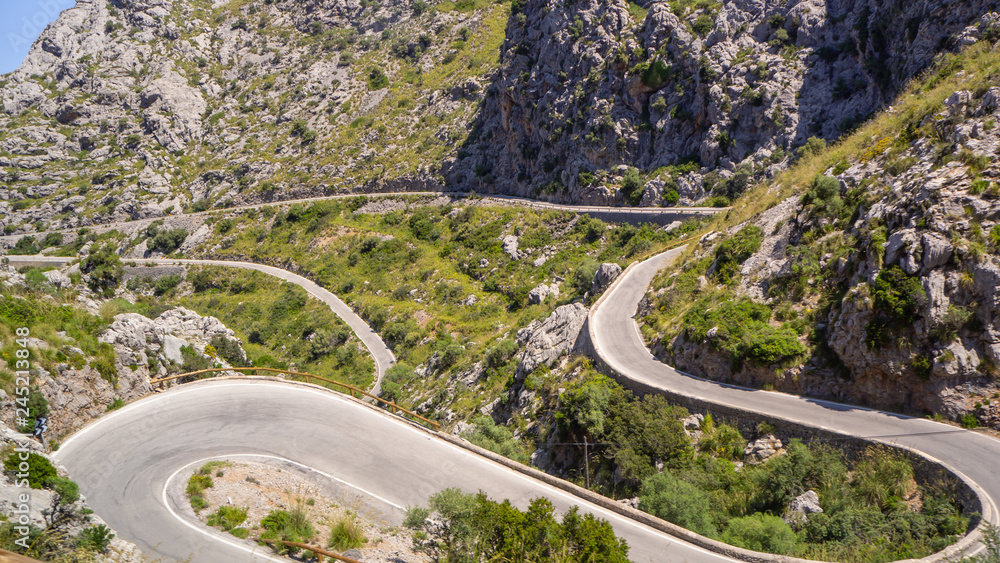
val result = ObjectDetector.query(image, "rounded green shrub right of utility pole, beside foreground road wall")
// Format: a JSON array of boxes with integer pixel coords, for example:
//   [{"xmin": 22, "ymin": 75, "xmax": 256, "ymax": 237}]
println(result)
[{"xmin": 639, "ymin": 473, "xmax": 717, "ymax": 537}]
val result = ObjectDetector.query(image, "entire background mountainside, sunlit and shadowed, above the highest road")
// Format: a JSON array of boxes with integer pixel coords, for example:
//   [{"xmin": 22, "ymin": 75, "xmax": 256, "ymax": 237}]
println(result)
[{"xmin": 0, "ymin": 0, "xmax": 995, "ymax": 233}]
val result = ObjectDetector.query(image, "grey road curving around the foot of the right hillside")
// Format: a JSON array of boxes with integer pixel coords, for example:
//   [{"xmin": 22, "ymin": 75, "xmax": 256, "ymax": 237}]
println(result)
[{"xmin": 588, "ymin": 247, "xmax": 1000, "ymax": 548}]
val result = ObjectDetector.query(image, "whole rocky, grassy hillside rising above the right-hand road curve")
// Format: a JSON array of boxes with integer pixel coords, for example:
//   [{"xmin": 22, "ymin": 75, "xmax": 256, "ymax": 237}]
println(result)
[{"xmin": 643, "ymin": 41, "xmax": 1000, "ymax": 428}]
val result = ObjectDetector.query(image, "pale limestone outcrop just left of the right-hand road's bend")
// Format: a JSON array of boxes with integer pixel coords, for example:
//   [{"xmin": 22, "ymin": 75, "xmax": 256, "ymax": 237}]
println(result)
[{"xmin": 517, "ymin": 303, "xmax": 587, "ymax": 376}]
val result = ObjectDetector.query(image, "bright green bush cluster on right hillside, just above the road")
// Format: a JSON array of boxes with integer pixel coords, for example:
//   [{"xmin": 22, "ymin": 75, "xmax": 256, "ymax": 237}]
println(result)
[{"xmin": 684, "ymin": 297, "xmax": 805, "ymax": 367}]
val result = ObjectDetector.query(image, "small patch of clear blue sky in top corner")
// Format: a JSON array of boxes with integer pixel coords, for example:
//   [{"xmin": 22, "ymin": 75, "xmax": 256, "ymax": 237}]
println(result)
[{"xmin": 0, "ymin": 0, "xmax": 76, "ymax": 74}]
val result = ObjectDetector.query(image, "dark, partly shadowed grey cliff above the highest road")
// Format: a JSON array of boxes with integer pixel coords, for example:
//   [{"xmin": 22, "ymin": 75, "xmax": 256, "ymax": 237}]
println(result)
[{"xmin": 445, "ymin": 0, "xmax": 996, "ymax": 206}]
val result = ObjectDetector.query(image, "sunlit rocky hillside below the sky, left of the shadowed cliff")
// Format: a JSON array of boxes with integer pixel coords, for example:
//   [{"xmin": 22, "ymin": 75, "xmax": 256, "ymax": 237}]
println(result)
[{"xmin": 0, "ymin": 0, "xmax": 507, "ymax": 232}]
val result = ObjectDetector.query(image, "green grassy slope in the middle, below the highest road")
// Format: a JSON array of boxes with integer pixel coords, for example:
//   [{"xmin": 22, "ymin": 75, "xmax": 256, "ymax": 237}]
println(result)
[{"xmin": 182, "ymin": 199, "xmax": 696, "ymax": 417}]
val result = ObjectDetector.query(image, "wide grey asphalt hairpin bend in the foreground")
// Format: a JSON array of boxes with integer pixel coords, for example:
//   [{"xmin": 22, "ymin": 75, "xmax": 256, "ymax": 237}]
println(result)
[{"xmin": 48, "ymin": 379, "xmax": 727, "ymax": 563}]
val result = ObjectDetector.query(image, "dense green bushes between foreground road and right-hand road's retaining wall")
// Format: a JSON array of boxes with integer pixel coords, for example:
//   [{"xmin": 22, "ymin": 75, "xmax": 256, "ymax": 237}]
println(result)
[{"xmin": 556, "ymin": 374, "xmax": 968, "ymax": 563}]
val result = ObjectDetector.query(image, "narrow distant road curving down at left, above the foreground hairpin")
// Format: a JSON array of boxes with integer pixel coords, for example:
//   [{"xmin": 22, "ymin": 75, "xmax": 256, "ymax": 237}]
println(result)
[{"xmin": 6, "ymin": 255, "xmax": 396, "ymax": 395}]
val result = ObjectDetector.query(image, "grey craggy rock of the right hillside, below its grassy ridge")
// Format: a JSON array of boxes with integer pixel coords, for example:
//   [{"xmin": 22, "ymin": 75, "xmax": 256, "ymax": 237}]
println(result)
[{"xmin": 648, "ymin": 82, "xmax": 1000, "ymax": 424}]
